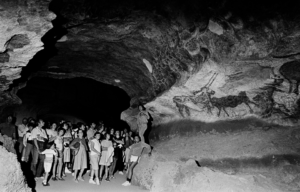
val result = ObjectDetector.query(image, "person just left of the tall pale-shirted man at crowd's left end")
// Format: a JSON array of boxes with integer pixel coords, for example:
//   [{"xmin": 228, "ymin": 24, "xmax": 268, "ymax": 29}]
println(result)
[{"xmin": 21, "ymin": 123, "xmax": 35, "ymax": 163}]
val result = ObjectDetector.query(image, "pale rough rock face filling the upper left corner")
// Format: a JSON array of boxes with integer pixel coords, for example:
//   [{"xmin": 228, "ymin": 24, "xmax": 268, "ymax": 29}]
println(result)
[{"xmin": 0, "ymin": 0, "xmax": 55, "ymax": 111}]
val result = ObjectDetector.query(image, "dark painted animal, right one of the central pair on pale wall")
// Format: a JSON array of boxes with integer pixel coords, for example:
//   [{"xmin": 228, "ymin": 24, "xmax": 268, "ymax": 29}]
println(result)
[{"xmin": 208, "ymin": 91, "xmax": 256, "ymax": 116}]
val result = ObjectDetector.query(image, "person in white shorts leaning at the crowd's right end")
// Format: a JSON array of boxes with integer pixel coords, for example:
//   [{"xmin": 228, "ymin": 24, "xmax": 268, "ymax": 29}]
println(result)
[{"xmin": 122, "ymin": 135, "xmax": 151, "ymax": 186}]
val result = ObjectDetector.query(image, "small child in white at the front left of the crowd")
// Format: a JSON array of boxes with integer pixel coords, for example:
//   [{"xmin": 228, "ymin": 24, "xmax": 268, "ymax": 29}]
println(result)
[{"xmin": 42, "ymin": 143, "xmax": 57, "ymax": 186}]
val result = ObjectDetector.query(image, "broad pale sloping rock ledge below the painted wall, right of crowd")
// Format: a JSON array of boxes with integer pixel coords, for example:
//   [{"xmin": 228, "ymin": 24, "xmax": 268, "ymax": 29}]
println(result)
[{"xmin": 135, "ymin": 118, "xmax": 300, "ymax": 192}]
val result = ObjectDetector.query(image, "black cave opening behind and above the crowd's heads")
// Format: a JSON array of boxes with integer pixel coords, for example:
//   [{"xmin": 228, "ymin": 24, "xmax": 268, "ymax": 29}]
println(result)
[{"xmin": 17, "ymin": 77, "xmax": 130, "ymax": 127}]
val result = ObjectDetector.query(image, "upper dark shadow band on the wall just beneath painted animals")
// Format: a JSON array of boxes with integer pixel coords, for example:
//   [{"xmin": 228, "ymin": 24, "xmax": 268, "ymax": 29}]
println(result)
[{"xmin": 149, "ymin": 118, "xmax": 278, "ymax": 141}]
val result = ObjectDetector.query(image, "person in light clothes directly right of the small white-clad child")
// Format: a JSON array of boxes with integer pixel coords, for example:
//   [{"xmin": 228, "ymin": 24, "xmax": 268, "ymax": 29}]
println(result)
[{"xmin": 52, "ymin": 128, "xmax": 65, "ymax": 181}]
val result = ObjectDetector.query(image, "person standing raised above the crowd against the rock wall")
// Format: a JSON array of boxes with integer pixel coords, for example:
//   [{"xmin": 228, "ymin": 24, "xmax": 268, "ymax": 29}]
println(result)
[{"xmin": 137, "ymin": 105, "xmax": 150, "ymax": 143}]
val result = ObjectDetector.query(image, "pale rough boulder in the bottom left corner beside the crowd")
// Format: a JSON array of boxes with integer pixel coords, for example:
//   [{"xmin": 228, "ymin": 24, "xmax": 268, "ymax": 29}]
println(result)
[{"xmin": 0, "ymin": 146, "xmax": 31, "ymax": 192}]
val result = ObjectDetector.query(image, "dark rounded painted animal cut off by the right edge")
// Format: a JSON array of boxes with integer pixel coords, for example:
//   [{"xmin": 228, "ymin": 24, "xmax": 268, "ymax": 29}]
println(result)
[{"xmin": 279, "ymin": 60, "xmax": 300, "ymax": 95}]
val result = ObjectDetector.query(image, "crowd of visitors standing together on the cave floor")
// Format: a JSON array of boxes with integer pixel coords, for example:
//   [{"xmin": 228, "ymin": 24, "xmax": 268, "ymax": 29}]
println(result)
[{"xmin": 0, "ymin": 114, "xmax": 151, "ymax": 186}]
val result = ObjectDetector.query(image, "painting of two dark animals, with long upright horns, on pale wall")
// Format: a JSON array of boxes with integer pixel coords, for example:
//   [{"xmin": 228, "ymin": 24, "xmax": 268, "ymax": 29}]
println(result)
[{"xmin": 173, "ymin": 73, "xmax": 256, "ymax": 117}]
